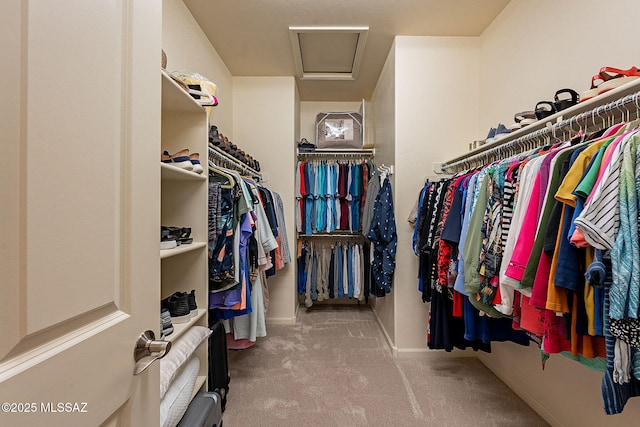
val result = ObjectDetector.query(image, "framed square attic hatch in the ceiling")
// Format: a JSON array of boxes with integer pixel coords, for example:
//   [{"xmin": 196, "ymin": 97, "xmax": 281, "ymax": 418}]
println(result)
[{"xmin": 289, "ymin": 27, "xmax": 369, "ymax": 80}]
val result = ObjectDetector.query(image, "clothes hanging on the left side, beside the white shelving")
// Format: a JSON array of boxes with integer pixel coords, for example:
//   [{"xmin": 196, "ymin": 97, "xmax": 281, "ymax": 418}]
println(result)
[{"xmin": 208, "ymin": 167, "xmax": 291, "ymax": 348}]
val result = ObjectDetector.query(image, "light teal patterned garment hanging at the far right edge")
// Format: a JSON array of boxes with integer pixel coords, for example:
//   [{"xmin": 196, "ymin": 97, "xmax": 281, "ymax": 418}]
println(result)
[{"xmin": 609, "ymin": 134, "xmax": 640, "ymax": 320}]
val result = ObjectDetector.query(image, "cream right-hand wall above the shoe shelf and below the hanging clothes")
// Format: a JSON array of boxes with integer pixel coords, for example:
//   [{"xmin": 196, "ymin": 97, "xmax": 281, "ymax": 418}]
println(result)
[{"xmin": 478, "ymin": 0, "xmax": 640, "ymax": 426}]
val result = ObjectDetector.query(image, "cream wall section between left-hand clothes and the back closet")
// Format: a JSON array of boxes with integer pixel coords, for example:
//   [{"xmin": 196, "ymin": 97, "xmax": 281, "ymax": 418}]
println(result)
[{"xmin": 233, "ymin": 77, "xmax": 297, "ymax": 323}]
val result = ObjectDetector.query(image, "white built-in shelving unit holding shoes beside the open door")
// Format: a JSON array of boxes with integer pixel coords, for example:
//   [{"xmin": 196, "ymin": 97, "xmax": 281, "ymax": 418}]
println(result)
[{"xmin": 158, "ymin": 68, "xmax": 208, "ymax": 395}]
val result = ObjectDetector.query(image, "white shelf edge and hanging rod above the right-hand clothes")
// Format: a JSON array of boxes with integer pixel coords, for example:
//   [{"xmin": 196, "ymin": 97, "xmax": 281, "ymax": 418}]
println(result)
[{"xmin": 436, "ymin": 79, "xmax": 640, "ymax": 173}]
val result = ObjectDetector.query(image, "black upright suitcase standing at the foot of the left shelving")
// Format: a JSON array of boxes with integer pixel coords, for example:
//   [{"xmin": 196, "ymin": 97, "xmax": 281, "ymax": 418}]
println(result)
[{"xmin": 209, "ymin": 320, "xmax": 231, "ymax": 412}]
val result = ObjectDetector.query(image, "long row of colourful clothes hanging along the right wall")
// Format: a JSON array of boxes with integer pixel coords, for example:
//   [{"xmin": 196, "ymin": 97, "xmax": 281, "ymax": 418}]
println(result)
[{"xmin": 412, "ymin": 124, "xmax": 640, "ymax": 414}]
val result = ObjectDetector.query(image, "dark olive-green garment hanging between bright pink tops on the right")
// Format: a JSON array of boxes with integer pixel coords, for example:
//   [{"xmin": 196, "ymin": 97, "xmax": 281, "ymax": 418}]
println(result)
[{"xmin": 518, "ymin": 147, "xmax": 577, "ymax": 288}]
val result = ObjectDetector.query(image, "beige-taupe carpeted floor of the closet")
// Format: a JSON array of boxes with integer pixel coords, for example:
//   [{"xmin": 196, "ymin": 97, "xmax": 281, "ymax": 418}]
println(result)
[{"xmin": 223, "ymin": 306, "xmax": 548, "ymax": 427}]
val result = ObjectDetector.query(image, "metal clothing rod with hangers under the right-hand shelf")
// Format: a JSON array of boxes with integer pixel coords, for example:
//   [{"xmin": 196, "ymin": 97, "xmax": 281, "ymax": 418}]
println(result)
[{"xmin": 440, "ymin": 79, "xmax": 640, "ymax": 173}]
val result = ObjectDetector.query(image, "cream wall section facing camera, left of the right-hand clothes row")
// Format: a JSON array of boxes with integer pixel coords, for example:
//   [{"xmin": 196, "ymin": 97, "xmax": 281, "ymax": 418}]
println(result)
[{"xmin": 390, "ymin": 36, "xmax": 479, "ymax": 353}]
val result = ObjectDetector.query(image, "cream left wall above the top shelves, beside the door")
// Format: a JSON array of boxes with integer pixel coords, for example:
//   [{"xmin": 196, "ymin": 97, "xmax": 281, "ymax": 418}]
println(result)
[{"xmin": 158, "ymin": 0, "xmax": 233, "ymax": 133}]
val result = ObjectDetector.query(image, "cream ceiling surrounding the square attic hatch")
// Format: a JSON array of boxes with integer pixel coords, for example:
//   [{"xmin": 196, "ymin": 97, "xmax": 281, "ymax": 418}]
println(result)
[{"xmin": 184, "ymin": 0, "xmax": 509, "ymax": 101}]
